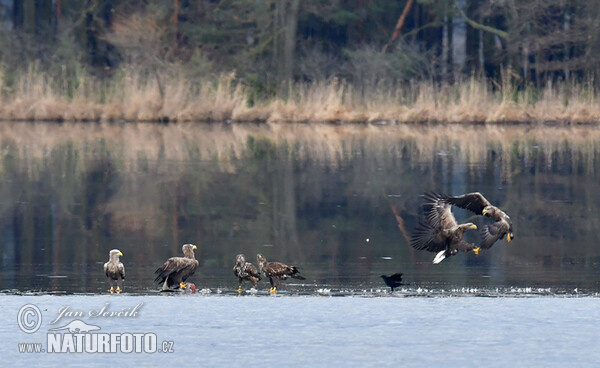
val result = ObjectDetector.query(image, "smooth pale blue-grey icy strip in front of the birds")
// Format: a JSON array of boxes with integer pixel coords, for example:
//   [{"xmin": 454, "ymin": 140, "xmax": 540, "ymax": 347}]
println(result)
[{"xmin": 0, "ymin": 294, "xmax": 600, "ymax": 367}]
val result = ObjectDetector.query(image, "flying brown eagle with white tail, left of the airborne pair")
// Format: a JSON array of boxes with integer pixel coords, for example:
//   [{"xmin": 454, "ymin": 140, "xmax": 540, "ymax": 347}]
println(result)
[{"xmin": 410, "ymin": 193, "xmax": 479, "ymax": 264}]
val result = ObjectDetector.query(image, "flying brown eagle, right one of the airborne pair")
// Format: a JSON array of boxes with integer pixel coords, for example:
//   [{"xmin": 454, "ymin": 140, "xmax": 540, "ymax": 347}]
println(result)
[{"xmin": 431, "ymin": 192, "xmax": 515, "ymax": 249}]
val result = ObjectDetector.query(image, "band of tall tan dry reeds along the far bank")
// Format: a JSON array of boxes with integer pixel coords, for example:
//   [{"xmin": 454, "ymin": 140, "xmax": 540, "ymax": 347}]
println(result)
[{"xmin": 0, "ymin": 68, "xmax": 600, "ymax": 124}]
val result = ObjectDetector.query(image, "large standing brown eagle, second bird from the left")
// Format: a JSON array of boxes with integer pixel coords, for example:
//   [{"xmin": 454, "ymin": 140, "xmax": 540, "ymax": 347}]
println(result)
[{"xmin": 154, "ymin": 244, "xmax": 198, "ymax": 291}]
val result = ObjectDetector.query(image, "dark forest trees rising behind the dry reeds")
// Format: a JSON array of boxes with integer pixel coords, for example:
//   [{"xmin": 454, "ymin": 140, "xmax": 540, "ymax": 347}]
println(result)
[{"xmin": 0, "ymin": 0, "xmax": 600, "ymax": 96}]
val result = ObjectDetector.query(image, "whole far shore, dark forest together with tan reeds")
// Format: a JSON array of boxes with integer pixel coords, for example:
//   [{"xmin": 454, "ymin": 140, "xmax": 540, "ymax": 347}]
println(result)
[{"xmin": 0, "ymin": 0, "xmax": 600, "ymax": 124}]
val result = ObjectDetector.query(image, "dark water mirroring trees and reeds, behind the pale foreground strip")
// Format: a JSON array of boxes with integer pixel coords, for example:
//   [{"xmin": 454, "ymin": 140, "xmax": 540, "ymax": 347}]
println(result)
[{"xmin": 0, "ymin": 123, "xmax": 600, "ymax": 292}]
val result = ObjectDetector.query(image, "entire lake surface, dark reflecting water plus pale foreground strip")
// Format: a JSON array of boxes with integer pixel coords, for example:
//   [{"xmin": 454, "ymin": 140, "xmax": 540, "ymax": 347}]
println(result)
[{"xmin": 0, "ymin": 123, "xmax": 600, "ymax": 367}]
